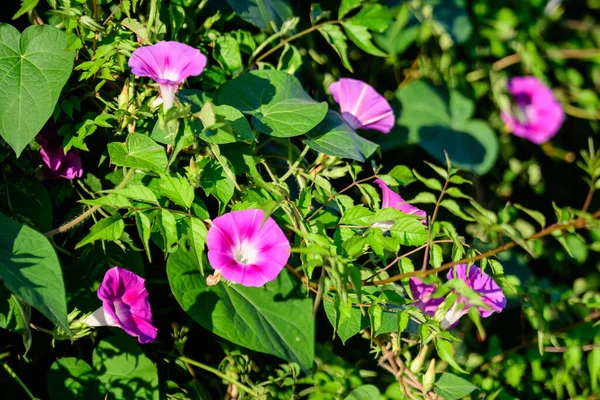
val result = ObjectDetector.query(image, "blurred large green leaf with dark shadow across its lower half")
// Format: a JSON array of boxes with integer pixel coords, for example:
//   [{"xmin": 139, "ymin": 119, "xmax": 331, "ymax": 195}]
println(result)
[{"xmin": 392, "ymin": 81, "xmax": 498, "ymax": 175}]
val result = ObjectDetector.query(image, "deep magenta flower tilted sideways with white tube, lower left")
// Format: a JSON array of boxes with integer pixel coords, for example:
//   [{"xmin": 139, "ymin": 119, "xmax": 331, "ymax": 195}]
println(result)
[{"xmin": 83, "ymin": 267, "xmax": 158, "ymax": 344}]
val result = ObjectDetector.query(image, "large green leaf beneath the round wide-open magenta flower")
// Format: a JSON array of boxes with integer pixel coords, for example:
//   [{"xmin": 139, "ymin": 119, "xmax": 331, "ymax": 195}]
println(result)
[{"xmin": 167, "ymin": 248, "xmax": 315, "ymax": 372}]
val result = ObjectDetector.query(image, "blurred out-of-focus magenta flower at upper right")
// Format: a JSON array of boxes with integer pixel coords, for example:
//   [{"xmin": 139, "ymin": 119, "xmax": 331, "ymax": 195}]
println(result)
[{"xmin": 502, "ymin": 76, "xmax": 565, "ymax": 144}]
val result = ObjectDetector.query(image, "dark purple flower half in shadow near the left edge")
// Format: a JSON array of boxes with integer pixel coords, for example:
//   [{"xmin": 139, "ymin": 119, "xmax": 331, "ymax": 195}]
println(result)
[{"xmin": 37, "ymin": 131, "xmax": 83, "ymax": 179}]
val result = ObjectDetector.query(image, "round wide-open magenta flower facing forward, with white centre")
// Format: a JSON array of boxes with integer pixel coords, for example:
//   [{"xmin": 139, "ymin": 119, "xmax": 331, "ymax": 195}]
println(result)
[{"xmin": 206, "ymin": 209, "xmax": 290, "ymax": 286}]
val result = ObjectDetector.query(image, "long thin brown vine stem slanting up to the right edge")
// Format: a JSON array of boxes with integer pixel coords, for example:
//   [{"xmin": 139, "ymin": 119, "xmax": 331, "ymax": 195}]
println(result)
[{"xmin": 363, "ymin": 210, "xmax": 600, "ymax": 286}]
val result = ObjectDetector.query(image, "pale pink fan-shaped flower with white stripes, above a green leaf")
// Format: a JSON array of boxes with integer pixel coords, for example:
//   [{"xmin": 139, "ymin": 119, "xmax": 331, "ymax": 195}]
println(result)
[{"xmin": 329, "ymin": 78, "xmax": 395, "ymax": 133}]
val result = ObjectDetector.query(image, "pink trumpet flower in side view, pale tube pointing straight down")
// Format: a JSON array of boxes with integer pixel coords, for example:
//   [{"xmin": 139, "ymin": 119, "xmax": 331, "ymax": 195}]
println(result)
[{"xmin": 129, "ymin": 41, "xmax": 206, "ymax": 110}]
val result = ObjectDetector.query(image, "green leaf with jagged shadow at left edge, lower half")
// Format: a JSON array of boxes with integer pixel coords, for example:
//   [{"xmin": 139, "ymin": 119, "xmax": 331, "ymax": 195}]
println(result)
[{"xmin": 0, "ymin": 214, "xmax": 69, "ymax": 331}]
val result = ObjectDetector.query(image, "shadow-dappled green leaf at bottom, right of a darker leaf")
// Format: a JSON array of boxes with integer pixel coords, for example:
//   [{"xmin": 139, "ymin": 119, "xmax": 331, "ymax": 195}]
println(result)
[{"xmin": 93, "ymin": 334, "xmax": 159, "ymax": 400}]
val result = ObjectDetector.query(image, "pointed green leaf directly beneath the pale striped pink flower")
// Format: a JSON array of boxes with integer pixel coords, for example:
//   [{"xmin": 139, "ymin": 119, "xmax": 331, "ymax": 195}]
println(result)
[{"xmin": 305, "ymin": 111, "xmax": 379, "ymax": 162}]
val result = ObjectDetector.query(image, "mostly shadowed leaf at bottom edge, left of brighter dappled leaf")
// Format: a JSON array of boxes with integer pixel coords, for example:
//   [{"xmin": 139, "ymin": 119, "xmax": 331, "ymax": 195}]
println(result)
[{"xmin": 46, "ymin": 357, "xmax": 106, "ymax": 400}]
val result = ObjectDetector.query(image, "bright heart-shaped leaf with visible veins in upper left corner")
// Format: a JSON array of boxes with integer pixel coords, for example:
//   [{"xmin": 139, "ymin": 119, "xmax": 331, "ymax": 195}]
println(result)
[{"xmin": 0, "ymin": 24, "xmax": 74, "ymax": 156}]
